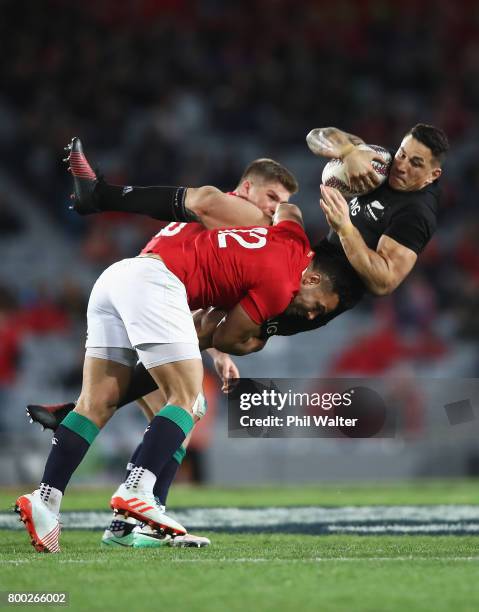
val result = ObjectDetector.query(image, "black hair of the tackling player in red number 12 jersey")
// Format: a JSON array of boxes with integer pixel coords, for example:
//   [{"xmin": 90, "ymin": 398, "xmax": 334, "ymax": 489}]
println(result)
[{"xmin": 313, "ymin": 238, "xmax": 365, "ymax": 311}]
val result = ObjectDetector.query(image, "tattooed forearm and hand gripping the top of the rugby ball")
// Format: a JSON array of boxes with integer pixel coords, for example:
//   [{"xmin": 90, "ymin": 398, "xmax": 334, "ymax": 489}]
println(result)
[{"xmin": 306, "ymin": 127, "xmax": 382, "ymax": 193}]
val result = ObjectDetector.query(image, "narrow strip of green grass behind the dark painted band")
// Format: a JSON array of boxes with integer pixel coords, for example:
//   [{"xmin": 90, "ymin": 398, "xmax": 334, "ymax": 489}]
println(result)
[{"xmin": 0, "ymin": 479, "xmax": 479, "ymax": 511}]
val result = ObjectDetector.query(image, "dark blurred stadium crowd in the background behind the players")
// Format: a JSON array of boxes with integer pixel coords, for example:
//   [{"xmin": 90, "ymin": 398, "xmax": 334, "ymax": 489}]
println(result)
[{"xmin": 0, "ymin": 0, "xmax": 479, "ymax": 478}]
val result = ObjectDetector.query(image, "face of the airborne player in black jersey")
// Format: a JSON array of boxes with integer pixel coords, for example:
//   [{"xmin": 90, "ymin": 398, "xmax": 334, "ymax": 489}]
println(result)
[{"xmin": 389, "ymin": 134, "xmax": 441, "ymax": 191}]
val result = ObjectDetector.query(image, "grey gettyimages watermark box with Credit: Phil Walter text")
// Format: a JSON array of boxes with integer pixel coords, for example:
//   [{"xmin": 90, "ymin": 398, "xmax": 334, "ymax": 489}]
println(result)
[{"xmin": 228, "ymin": 378, "xmax": 479, "ymax": 438}]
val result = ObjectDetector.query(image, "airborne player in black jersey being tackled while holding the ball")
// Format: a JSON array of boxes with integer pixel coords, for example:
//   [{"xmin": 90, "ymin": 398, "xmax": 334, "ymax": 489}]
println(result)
[{"xmin": 29, "ymin": 124, "xmax": 448, "ymax": 544}]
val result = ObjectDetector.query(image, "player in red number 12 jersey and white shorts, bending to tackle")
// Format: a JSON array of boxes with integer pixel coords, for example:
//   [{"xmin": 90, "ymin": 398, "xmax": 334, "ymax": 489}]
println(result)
[{"xmin": 16, "ymin": 141, "xmax": 360, "ymax": 552}]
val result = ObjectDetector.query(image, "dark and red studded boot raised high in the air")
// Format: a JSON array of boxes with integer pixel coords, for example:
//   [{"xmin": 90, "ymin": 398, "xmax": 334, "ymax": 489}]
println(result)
[{"xmin": 63, "ymin": 136, "xmax": 100, "ymax": 215}]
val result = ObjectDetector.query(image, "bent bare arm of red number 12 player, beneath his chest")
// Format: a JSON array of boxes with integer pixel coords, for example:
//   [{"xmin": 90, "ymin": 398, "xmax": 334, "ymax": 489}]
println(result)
[{"xmin": 212, "ymin": 304, "xmax": 266, "ymax": 355}]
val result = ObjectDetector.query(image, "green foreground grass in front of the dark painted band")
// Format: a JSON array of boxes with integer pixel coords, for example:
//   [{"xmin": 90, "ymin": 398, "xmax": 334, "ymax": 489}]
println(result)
[{"xmin": 0, "ymin": 531, "xmax": 479, "ymax": 612}]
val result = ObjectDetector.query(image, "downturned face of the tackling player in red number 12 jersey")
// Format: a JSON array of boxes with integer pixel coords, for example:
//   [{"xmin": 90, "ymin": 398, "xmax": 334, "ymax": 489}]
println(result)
[{"xmin": 286, "ymin": 272, "xmax": 339, "ymax": 320}]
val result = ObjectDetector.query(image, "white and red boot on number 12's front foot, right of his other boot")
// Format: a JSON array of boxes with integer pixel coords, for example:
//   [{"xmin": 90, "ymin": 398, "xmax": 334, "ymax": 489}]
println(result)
[{"xmin": 110, "ymin": 484, "xmax": 186, "ymax": 536}]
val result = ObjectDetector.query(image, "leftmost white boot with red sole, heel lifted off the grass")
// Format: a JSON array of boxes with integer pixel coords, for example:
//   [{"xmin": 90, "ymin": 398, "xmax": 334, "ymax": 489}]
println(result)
[{"xmin": 15, "ymin": 489, "xmax": 61, "ymax": 553}]
